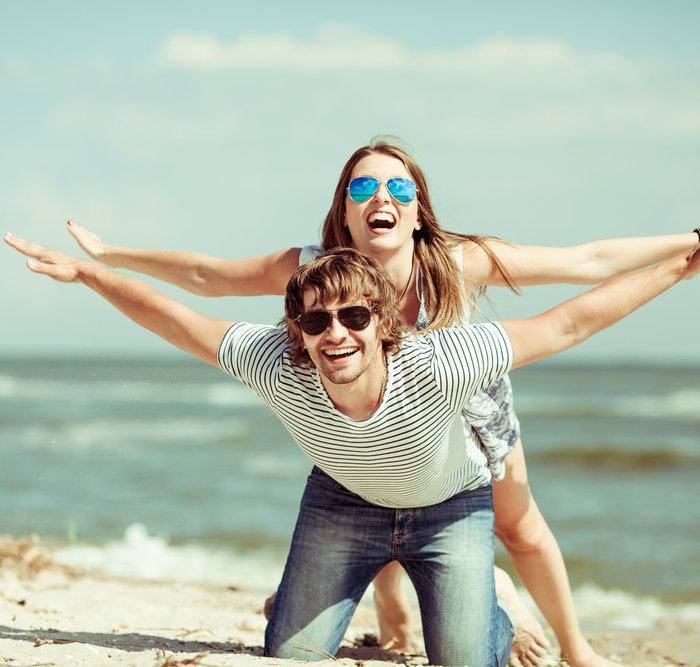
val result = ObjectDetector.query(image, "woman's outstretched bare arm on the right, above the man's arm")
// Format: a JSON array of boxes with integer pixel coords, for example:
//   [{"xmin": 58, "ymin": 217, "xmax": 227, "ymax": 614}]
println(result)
[{"xmin": 464, "ymin": 231, "xmax": 700, "ymax": 286}]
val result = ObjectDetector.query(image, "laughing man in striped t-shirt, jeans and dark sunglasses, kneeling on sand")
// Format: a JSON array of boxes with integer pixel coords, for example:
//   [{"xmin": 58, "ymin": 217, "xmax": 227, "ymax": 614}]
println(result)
[{"xmin": 5, "ymin": 236, "xmax": 700, "ymax": 667}]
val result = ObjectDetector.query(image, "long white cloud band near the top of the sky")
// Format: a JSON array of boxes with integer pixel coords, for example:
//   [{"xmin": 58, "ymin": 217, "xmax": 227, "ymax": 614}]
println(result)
[{"xmin": 158, "ymin": 25, "xmax": 638, "ymax": 81}]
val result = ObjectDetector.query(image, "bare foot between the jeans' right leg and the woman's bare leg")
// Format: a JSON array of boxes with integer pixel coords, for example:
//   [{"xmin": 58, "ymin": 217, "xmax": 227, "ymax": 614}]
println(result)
[{"xmin": 494, "ymin": 567, "xmax": 550, "ymax": 667}]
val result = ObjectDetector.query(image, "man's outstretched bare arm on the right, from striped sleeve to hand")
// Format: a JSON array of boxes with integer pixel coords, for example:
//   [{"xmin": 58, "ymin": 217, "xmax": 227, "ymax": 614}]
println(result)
[{"xmin": 502, "ymin": 245, "xmax": 700, "ymax": 368}]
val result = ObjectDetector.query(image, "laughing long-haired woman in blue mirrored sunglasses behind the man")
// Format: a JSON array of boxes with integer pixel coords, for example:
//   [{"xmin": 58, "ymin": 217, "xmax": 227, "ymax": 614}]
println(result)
[{"xmin": 69, "ymin": 137, "xmax": 700, "ymax": 667}]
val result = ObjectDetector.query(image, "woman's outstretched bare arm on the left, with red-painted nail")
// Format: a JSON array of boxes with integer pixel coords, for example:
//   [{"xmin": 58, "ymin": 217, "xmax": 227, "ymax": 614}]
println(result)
[{"xmin": 67, "ymin": 220, "xmax": 300, "ymax": 296}]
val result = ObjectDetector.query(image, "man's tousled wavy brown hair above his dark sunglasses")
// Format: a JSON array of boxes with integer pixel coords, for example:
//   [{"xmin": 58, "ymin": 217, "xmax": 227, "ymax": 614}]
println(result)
[{"xmin": 283, "ymin": 248, "xmax": 406, "ymax": 366}]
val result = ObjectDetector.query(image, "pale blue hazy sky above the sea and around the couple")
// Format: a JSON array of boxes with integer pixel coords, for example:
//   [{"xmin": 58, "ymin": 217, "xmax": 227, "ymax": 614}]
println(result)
[{"xmin": 0, "ymin": 0, "xmax": 700, "ymax": 364}]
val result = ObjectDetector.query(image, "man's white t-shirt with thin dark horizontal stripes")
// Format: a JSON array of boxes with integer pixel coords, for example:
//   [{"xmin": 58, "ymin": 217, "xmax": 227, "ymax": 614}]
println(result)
[{"xmin": 218, "ymin": 322, "xmax": 512, "ymax": 507}]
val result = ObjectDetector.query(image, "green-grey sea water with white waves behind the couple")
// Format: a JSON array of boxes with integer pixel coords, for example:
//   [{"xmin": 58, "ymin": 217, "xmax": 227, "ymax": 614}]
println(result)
[{"xmin": 0, "ymin": 357, "xmax": 700, "ymax": 628}]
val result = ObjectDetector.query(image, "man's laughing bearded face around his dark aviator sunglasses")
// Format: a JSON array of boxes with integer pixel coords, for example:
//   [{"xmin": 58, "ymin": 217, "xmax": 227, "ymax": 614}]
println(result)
[{"xmin": 302, "ymin": 291, "xmax": 384, "ymax": 384}]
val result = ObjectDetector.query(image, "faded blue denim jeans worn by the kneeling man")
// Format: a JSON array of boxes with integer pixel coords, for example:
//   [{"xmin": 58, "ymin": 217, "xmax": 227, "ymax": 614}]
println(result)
[{"xmin": 265, "ymin": 468, "xmax": 513, "ymax": 667}]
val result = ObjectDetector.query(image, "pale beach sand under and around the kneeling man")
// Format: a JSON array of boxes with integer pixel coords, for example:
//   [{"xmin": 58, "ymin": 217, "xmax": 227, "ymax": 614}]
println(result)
[{"xmin": 0, "ymin": 538, "xmax": 700, "ymax": 667}]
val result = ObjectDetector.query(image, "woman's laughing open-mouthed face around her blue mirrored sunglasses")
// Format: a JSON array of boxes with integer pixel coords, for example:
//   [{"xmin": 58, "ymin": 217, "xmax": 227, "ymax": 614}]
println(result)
[{"xmin": 345, "ymin": 153, "xmax": 421, "ymax": 256}]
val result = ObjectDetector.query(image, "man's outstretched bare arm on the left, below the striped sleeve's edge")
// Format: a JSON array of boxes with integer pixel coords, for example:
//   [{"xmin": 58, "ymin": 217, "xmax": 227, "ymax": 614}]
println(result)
[{"xmin": 5, "ymin": 234, "xmax": 233, "ymax": 366}]
